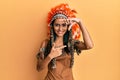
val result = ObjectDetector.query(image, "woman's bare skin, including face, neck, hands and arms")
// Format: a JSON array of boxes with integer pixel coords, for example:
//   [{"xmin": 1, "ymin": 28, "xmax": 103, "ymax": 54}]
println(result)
[{"xmin": 38, "ymin": 18, "xmax": 93, "ymax": 71}]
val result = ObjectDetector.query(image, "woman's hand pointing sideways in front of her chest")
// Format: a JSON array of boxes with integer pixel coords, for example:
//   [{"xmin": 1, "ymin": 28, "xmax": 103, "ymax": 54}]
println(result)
[{"xmin": 49, "ymin": 43, "xmax": 66, "ymax": 59}]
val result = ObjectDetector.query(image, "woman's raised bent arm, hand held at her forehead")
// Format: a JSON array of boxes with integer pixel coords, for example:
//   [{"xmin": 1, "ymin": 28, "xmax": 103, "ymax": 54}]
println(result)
[{"xmin": 71, "ymin": 18, "xmax": 94, "ymax": 50}]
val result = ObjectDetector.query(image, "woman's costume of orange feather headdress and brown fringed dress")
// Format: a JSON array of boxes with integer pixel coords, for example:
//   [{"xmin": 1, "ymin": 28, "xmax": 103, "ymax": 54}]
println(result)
[{"xmin": 37, "ymin": 4, "xmax": 82, "ymax": 80}]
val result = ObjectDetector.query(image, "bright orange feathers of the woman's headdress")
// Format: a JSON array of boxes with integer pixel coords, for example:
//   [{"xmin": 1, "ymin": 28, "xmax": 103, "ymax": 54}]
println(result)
[{"xmin": 47, "ymin": 3, "xmax": 80, "ymax": 40}]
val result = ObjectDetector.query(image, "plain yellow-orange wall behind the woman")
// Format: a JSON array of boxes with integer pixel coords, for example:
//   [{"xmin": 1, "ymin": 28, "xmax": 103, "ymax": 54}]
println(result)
[{"xmin": 0, "ymin": 0, "xmax": 120, "ymax": 80}]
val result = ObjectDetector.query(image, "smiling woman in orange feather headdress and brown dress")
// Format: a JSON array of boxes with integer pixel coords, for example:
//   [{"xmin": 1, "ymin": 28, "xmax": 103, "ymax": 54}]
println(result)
[{"xmin": 37, "ymin": 4, "xmax": 93, "ymax": 80}]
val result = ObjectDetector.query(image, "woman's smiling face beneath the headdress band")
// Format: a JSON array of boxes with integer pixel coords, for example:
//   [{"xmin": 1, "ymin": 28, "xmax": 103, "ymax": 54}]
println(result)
[{"xmin": 53, "ymin": 18, "xmax": 68, "ymax": 37}]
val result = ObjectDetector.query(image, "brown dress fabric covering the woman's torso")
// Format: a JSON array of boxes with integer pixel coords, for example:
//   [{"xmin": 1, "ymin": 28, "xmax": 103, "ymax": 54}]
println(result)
[{"xmin": 45, "ymin": 53, "xmax": 73, "ymax": 80}]
